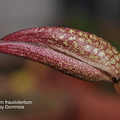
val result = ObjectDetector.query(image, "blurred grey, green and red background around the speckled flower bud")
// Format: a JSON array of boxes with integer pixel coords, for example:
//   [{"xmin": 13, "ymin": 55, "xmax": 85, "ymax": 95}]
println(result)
[{"xmin": 0, "ymin": 0, "xmax": 120, "ymax": 120}]
